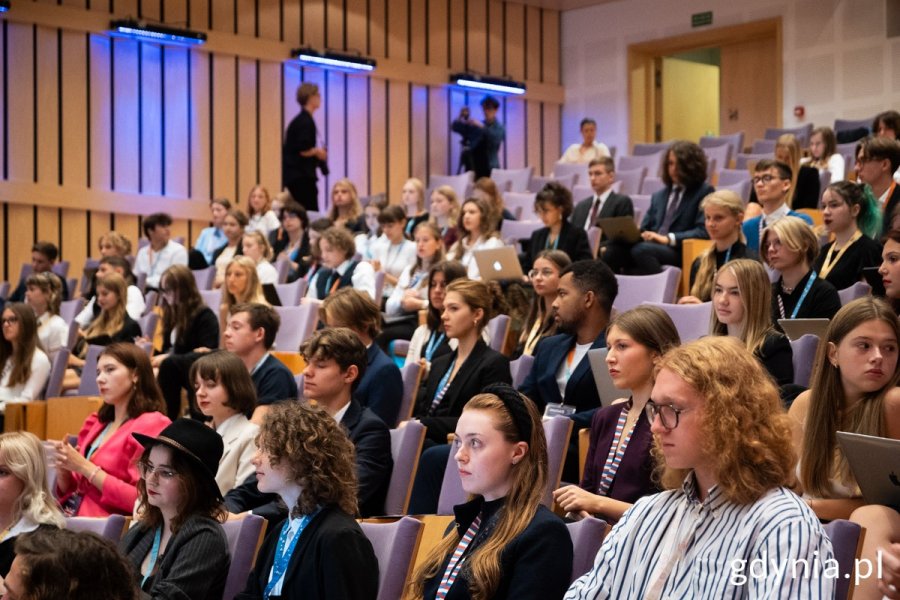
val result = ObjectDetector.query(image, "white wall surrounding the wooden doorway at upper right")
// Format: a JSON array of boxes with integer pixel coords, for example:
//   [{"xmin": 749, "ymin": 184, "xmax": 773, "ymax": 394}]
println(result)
[{"xmin": 560, "ymin": 0, "xmax": 900, "ymax": 155}]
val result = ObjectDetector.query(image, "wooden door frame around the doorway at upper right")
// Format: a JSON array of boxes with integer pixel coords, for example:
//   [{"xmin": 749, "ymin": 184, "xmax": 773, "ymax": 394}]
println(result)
[{"xmin": 628, "ymin": 17, "xmax": 784, "ymax": 148}]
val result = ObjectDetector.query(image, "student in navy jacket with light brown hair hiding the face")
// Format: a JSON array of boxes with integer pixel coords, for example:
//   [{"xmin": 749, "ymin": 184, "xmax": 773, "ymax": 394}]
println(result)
[{"xmin": 319, "ymin": 288, "xmax": 403, "ymax": 427}]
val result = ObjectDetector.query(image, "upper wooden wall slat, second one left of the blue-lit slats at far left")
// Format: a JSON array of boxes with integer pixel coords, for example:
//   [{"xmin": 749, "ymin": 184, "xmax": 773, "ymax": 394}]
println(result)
[{"xmin": 35, "ymin": 27, "xmax": 61, "ymax": 183}]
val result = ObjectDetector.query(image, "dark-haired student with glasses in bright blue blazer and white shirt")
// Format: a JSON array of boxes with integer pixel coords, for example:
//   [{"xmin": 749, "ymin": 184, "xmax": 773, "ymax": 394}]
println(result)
[{"xmin": 743, "ymin": 159, "xmax": 813, "ymax": 252}]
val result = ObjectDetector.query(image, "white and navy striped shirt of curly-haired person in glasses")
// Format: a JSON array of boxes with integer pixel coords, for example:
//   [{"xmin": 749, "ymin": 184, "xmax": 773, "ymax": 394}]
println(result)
[{"xmin": 565, "ymin": 473, "xmax": 838, "ymax": 600}]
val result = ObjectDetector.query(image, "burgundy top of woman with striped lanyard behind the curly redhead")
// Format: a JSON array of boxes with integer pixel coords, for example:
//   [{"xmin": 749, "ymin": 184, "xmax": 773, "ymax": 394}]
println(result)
[{"xmin": 581, "ymin": 401, "xmax": 659, "ymax": 504}]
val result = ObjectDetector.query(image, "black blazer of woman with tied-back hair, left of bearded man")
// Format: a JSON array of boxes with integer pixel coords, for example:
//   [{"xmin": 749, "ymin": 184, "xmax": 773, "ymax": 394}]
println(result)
[{"xmin": 415, "ymin": 338, "xmax": 512, "ymax": 444}]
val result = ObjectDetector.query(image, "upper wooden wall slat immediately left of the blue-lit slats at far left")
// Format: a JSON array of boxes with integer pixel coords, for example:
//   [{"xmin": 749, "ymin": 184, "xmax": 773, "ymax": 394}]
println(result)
[{"xmin": 60, "ymin": 31, "xmax": 88, "ymax": 186}]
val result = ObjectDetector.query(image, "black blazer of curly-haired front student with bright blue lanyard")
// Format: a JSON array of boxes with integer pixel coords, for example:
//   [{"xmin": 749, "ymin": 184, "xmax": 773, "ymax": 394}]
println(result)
[{"xmin": 234, "ymin": 506, "xmax": 378, "ymax": 600}]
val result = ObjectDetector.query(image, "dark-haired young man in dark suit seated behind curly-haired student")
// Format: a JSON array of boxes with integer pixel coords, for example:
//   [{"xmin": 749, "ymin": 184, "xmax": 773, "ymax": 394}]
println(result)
[{"xmin": 225, "ymin": 327, "xmax": 393, "ymax": 518}]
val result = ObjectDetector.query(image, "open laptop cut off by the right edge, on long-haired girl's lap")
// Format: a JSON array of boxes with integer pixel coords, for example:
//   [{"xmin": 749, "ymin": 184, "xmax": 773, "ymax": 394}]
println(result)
[{"xmin": 837, "ymin": 431, "xmax": 900, "ymax": 509}]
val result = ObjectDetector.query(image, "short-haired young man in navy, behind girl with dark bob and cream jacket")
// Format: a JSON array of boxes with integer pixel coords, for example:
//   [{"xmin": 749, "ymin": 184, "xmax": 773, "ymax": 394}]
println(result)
[{"xmin": 224, "ymin": 302, "xmax": 297, "ymax": 424}]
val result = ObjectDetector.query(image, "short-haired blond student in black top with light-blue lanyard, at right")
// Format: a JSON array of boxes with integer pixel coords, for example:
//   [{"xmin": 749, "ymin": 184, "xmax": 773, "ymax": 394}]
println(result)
[{"xmin": 762, "ymin": 217, "xmax": 841, "ymax": 323}]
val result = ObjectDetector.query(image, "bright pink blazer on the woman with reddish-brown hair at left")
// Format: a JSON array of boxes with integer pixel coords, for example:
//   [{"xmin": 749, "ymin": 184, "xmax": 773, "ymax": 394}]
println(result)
[{"xmin": 59, "ymin": 411, "xmax": 171, "ymax": 517}]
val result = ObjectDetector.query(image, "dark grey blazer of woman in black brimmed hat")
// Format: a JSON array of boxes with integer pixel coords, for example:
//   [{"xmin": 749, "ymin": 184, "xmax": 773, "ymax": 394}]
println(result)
[{"xmin": 119, "ymin": 515, "xmax": 231, "ymax": 600}]
